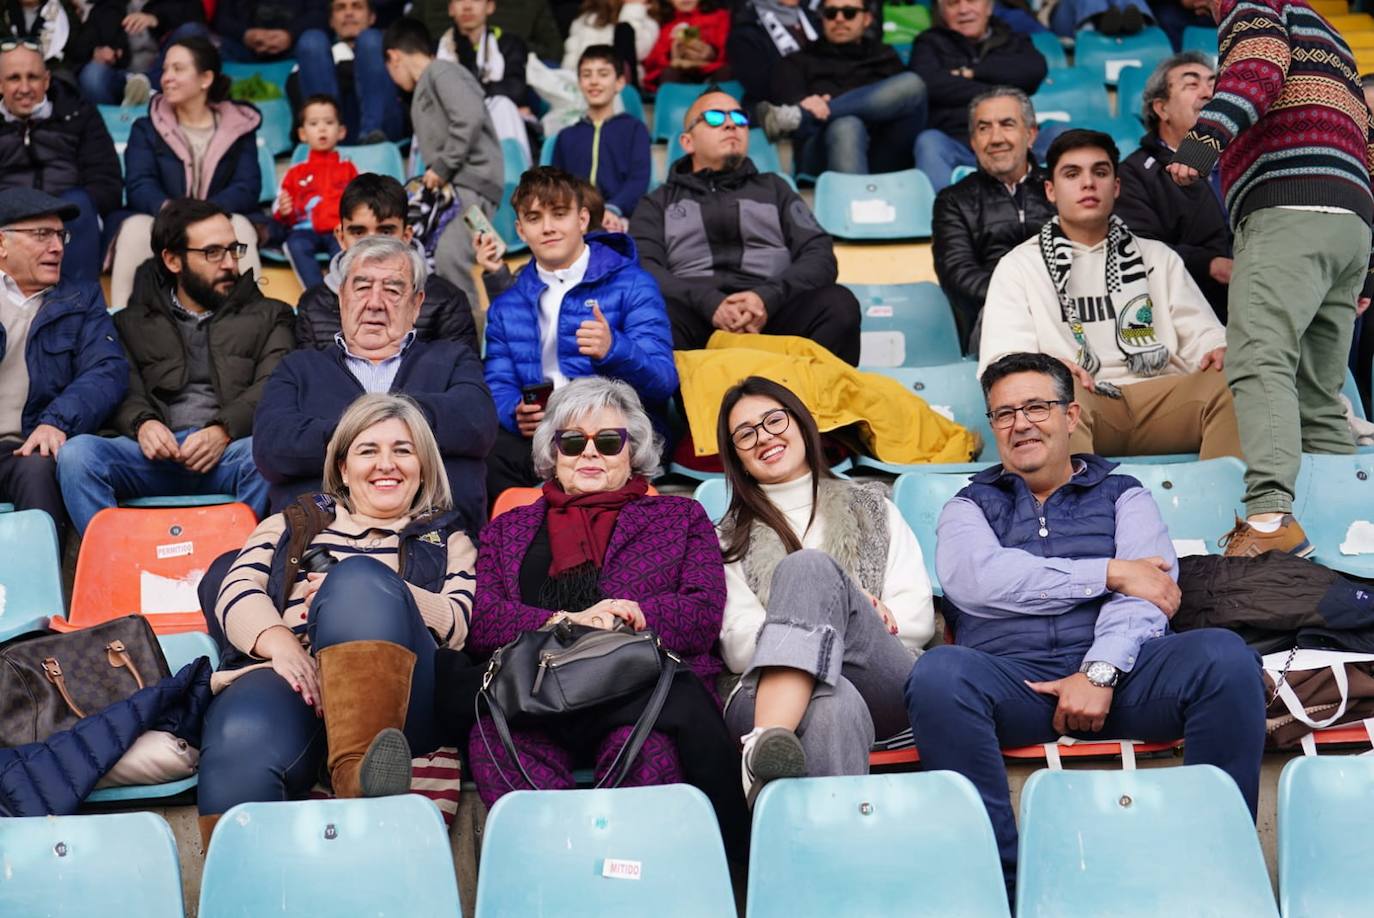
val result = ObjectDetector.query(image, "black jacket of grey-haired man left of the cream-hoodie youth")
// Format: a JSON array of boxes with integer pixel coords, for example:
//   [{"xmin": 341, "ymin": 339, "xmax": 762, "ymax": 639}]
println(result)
[{"xmin": 932, "ymin": 162, "xmax": 1055, "ymax": 350}]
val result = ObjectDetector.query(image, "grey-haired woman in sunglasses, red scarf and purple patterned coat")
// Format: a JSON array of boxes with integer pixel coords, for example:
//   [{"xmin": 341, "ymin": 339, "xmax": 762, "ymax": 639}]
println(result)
[{"xmin": 467, "ymin": 377, "xmax": 752, "ymax": 859}]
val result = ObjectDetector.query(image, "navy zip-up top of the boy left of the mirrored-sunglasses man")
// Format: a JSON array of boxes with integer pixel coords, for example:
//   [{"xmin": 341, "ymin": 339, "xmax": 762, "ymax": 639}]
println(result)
[{"xmin": 554, "ymin": 113, "xmax": 650, "ymax": 217}]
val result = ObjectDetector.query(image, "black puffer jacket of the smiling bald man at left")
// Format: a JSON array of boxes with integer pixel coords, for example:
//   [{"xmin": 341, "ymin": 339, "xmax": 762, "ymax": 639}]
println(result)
[{"xmin": 0, "ymin": 80, "xmax": 124, "ymax": 214}]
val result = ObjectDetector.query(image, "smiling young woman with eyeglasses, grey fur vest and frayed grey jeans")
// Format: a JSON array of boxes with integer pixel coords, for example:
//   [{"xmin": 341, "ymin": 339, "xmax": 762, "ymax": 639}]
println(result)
[{"xmin": 716, "ymin": 377, "xmax": 934, "ymax": 803}]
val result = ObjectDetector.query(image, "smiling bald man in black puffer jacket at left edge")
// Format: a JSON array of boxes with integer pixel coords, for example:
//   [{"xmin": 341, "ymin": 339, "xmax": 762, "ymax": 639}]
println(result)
[{"xmin": 0, "ymin": 40, "xmax": 124, "ymax": 282}]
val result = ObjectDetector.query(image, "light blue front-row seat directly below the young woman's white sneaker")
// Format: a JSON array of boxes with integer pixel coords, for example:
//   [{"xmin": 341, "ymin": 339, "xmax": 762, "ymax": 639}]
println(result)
[{"xmin": 741, "ymin": 771, "xmax": 1010, "ymax": 918}]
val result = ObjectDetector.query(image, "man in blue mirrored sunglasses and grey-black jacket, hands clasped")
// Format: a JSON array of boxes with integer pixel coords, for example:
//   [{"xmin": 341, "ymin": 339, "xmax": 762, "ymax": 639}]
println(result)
[{"xmin": 631, "ymin": 89, "xmax": 859, "ymax": 366}]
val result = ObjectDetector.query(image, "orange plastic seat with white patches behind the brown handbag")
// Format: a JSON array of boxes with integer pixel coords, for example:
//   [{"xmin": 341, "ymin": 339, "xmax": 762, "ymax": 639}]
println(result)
[{"xmin": 51, "ymin": 503, "xmax": 257, "ymax": 635}]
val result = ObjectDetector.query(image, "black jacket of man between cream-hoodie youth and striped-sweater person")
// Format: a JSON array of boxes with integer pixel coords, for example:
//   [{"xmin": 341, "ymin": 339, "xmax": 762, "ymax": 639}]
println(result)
[{"xmin": 1116, "ymin": 133, "xmax": 1231, "ymax": 324}]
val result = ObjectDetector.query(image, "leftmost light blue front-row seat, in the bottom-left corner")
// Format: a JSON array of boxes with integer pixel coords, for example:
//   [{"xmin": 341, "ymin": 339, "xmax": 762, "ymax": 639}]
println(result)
[{"xmin": 0, "ymin": 812, "xmax": 185, "ymax": 918}]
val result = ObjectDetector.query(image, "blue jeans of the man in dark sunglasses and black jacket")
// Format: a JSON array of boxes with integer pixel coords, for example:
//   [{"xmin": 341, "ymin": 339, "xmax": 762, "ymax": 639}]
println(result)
[{"xmin": 796, "ymin": 71, "xmax": 926, "ymax": 176}]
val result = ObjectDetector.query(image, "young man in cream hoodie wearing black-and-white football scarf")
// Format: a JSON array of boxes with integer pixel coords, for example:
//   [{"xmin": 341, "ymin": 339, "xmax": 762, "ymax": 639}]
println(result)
[{"xmin": 978, "ymin": 131, "xmax": 1241, "ymax": 459}]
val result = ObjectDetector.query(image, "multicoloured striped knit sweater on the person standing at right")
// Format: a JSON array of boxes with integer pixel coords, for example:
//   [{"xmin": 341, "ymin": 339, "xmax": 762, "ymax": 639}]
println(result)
[{"xmin": 1173, "ymin": 0, "xmax": 1374, "ymax": 227}]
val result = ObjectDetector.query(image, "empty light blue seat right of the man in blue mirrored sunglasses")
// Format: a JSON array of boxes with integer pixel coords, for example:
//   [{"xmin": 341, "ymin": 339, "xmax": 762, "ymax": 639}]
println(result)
[{"xmin": 815, "ymin": 169, "xmax": 936, "ymax": 239}]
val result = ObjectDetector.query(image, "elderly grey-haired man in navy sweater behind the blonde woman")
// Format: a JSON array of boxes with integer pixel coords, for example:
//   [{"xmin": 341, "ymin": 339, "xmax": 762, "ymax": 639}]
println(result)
[{"xmin": 253, "ymin": 236, "xmax": 496, "ymax": 532}]
